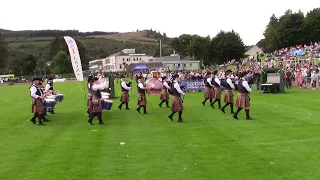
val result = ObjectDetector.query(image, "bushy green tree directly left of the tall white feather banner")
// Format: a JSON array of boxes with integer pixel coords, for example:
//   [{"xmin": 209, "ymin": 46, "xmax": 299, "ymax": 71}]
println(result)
[{"xmin": 52, "ymin": 51, "xmax": 72, "ymax": 74}]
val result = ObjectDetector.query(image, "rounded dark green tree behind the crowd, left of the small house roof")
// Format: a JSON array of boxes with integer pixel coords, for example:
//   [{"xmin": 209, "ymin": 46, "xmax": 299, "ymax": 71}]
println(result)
[{"xmin": 209, "ymin": 30, "xmax": 246, "ymax": 64}]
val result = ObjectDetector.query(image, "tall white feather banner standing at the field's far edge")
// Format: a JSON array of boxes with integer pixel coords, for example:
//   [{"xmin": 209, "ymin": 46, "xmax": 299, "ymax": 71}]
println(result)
[{"xmin": 64, "ymin": 36, "xmax": 83, "ymax": 81}]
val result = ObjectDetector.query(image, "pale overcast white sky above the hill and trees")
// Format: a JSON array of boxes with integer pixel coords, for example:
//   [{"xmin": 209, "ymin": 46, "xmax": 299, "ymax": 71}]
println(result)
[{"xmin": 0, "ymin": 0, "xmax": 320, "ymax": 45}]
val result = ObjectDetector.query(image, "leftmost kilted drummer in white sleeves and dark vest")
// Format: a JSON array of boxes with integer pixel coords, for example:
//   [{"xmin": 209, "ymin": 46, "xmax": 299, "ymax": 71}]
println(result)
[{"xmin": 30, "ymin": 78, "xmax": 45, "ymax": 125}]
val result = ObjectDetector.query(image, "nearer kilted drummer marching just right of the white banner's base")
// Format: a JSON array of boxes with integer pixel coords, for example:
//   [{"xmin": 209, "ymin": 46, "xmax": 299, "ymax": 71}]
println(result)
[{"xmin": 88, "ymin": 77, "xmax": 106, "ymax": 125}]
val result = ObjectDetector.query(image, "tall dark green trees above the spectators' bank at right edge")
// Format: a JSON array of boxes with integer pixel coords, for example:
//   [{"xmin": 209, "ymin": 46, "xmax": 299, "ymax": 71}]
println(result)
[{"xmin": 257, "ymin": 8, "xmax": 320, "ymax": 52}]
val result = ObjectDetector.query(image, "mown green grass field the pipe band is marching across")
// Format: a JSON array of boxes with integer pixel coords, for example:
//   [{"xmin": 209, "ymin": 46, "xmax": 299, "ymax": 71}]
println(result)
[{"xmin": 0, "ymin": 82, "xmax": 320, "ymax": 180}]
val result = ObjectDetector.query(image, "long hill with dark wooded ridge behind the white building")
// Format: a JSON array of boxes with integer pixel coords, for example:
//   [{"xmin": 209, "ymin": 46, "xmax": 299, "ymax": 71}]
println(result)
[{"xmin": 0, "ymin": 29, "xmax": 172, "ymax": 73}]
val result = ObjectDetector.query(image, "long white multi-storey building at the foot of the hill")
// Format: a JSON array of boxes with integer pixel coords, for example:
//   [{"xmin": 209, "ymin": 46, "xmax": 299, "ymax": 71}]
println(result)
[{"xmin": 89, "ymin": 50, "xmax": 149, "ymax": 72}]
